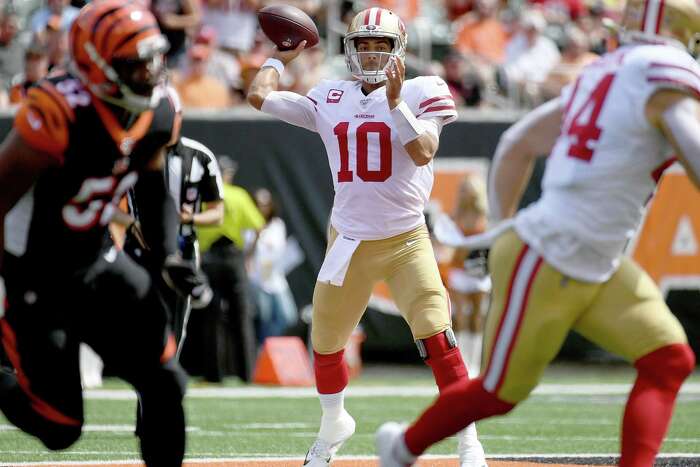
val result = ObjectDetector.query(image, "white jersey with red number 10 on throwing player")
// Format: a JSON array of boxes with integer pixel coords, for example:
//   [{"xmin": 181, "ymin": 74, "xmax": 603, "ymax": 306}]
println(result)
[{"xmin": 262, "ymin": 76, "xmax": 457, "ymax": 240}]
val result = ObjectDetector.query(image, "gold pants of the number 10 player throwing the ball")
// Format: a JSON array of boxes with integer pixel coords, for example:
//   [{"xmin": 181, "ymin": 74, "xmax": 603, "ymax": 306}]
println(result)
[{"xmin": 311, "ymin": 225, "xmax": 451, "ymax": 354}]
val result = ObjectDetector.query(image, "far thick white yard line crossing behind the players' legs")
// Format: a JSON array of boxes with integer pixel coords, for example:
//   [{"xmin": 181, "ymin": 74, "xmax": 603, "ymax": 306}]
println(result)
[{"xmin": 84, "ymin": 383, "xmax": 700, "ymax": 400}]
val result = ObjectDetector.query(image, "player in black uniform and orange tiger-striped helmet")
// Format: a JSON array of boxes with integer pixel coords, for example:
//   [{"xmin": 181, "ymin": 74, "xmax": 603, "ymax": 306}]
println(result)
[{"xmin": 0, "ymin": 0, "xmax": 204, "ymax": 467}]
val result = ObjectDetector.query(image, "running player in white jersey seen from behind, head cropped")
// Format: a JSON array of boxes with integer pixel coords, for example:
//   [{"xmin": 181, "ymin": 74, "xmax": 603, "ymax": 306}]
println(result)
[{"xmin": 378, "ymin": 0, "xmax": 700, "ymax": 467}]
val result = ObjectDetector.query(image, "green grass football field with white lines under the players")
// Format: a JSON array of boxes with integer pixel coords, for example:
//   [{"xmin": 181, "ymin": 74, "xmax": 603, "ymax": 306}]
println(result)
[{"xmin": 0, "ymin": 366, "xmax": 700, "ymax": 465}]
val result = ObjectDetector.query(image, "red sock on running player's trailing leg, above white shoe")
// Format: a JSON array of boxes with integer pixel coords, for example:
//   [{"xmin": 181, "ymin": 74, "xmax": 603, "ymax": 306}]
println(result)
[{"xmin": 405, "ymin": 378, "xmax": 515, "ymax": 455}]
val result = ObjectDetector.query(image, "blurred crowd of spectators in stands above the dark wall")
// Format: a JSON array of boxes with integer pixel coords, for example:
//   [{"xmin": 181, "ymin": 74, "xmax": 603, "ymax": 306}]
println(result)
[{"xmin": 0, "ymin": 0, "xmax": 622, "ymax": 111}]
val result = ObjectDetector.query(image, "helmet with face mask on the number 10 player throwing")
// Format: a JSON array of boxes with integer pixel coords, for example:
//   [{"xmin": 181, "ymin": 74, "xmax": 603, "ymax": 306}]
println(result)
[{"xmin": 344, "ymin": 7, "xmax": 407, "ymax": 84}]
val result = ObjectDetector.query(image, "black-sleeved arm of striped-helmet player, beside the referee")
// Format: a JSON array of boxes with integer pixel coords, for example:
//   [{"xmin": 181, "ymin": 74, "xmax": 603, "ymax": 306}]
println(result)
[{"xmin": 134, "ymin": 171, "xmax": 179, "ymax": 268}]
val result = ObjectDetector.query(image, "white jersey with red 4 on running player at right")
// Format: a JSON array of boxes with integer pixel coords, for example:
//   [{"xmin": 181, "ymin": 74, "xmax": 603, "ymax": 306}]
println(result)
[{"xmin": 515, "ymin": 44, "xmax": 700, "ymax": 282}]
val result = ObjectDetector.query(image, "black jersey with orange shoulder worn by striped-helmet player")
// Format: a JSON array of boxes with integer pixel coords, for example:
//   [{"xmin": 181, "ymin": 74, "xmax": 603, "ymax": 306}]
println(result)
[{"xmin": 9, "ymin": 73, "xmax": 176, "ymax": 271}]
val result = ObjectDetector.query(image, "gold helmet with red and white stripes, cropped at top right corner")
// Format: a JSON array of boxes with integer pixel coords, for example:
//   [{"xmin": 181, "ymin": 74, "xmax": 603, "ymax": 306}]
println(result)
[{"xmin": 622, "ymin": 0, "xmax": 700, "ymax": 56}]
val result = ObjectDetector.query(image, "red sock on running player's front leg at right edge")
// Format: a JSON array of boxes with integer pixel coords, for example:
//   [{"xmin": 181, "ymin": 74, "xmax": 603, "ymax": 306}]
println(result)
[{"xmin": 620, "ymin": 344, "xmax": 695, "ymax": 467}]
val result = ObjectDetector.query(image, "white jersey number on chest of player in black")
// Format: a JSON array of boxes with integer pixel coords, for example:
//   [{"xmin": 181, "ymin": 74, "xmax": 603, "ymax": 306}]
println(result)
[{"xmin": 61, "ymin": 172, "xmax": 138, "ymax": 232}]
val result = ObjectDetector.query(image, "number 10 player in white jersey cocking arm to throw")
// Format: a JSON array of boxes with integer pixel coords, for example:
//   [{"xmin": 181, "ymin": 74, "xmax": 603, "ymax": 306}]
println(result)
[{"xmin": 248, "ymin": 8, "xmax": 485, "ymax": 467}]
